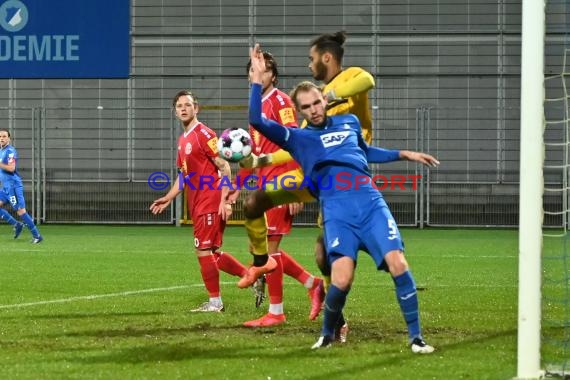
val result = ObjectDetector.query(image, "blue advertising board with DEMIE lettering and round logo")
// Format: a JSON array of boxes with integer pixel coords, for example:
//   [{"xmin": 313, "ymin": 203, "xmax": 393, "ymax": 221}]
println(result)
[{"xmin": 0, "ymin": 0, "xmax": 130, "ymax": 78}]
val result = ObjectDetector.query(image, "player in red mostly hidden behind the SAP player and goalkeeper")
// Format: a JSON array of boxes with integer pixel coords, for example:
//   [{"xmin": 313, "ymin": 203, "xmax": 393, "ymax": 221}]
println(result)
[{"xmin": 236, "ymin": 52, "xmax": 324, "ymax": 327}]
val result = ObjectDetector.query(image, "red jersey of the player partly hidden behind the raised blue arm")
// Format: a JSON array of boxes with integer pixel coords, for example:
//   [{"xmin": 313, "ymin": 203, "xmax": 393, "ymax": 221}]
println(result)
[{"xmin": 249, "ymin": 88, "xmax": 299, "ymax": 179}]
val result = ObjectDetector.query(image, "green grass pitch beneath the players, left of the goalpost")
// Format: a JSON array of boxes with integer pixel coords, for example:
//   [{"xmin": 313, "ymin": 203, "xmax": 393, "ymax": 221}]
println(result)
[{"xmin": 0, "ymin": 225, "xmax": 518, "ymax": 380}]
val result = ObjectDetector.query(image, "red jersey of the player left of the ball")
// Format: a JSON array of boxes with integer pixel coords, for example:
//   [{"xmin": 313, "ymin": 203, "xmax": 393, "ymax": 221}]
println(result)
[{"xmin": 176, "ymin": 122, "xmax": 222, "ymax": 217}]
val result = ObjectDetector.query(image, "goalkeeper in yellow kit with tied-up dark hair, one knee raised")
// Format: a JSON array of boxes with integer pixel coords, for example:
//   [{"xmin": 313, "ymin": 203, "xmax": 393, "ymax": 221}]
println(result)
[{"xmin": 238, "ymin": 31, "xmax": 374, "ymax": 341}]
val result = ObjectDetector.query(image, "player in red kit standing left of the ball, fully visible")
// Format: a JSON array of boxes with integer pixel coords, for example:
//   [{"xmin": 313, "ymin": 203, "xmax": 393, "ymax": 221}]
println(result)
[{"xmin": 150, "ymin": 90, "xmax": 247, "ymax": 312}]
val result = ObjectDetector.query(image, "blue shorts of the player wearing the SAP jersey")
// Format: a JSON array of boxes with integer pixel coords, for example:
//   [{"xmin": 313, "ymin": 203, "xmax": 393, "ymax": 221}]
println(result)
[{"xmin": 321, "ymin": 193, "xmax": 404, "ymax": 270}]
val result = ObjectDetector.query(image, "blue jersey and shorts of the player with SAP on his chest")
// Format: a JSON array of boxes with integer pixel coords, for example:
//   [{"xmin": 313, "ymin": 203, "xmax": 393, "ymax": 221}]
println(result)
[{"xmin": 249, "ymin": 84, "xmax": 404, "ymax": 262}]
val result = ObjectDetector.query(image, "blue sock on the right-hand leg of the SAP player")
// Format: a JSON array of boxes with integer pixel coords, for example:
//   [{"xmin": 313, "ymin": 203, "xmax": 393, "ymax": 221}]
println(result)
[{"xmin": 392, "ymin": 271, "xmax": 422, "ymax": 340}]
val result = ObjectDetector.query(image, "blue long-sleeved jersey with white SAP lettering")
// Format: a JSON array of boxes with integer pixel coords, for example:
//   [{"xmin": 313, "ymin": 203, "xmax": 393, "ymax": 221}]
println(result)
[{"xmin": 249, "ymin": 84, "xmax": 399, "ymax": 199}]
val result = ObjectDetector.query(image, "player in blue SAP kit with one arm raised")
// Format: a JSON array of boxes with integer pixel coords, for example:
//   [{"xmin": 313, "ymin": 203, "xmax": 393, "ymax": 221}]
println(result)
[{"xmin": 249, "ymin": 45, "xmax": 439, "ymax": 354}]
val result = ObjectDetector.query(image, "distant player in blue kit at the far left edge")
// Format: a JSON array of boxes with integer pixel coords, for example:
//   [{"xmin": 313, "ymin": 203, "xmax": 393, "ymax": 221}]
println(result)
[{"xmin": 0, "ymin": 129, "xmax": 44, "ymax": 244}]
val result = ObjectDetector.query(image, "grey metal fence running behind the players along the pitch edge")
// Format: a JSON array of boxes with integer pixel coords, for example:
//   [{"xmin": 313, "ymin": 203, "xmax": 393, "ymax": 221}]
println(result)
[{"xmin": 0, "ymin": 106, "xmax": 563, "ymax": 227}]
